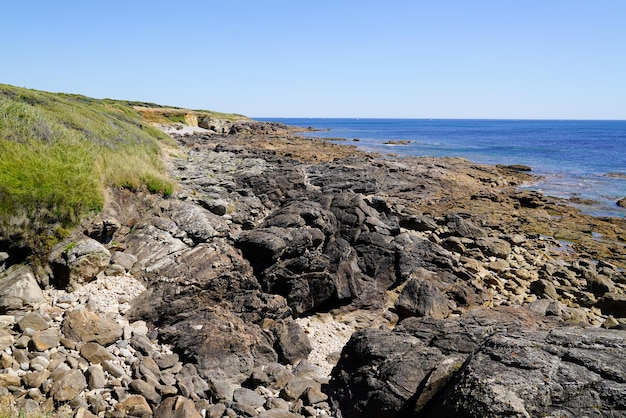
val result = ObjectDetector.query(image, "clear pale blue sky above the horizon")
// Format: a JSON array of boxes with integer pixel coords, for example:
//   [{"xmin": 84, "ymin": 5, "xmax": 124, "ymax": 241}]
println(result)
[{"xmin": 0, "ymin": 0, "xmax": 626, "ymax": 119}]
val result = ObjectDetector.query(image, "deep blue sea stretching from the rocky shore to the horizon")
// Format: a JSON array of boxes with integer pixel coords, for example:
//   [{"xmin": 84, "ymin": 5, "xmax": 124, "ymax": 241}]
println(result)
[{"xmin": 257, "ymin": 118, "xmax": 626, "ymax": 217}]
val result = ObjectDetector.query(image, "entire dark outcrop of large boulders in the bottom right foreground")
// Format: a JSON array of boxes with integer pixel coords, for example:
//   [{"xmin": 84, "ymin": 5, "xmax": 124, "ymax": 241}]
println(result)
[{"xmin": 330, "ymin": 308, "xmax": 626, "ymax": 418}]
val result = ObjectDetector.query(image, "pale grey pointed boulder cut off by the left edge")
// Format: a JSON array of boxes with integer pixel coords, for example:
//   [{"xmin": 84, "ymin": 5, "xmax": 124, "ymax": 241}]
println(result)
[{"xmin": 0, "ymin": 265, "xmax": 44, "ymax": 313}]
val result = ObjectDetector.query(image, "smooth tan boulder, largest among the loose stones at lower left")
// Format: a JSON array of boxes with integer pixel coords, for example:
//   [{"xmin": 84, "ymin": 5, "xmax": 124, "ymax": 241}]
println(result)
[{"xmin": 62, "ymin": 309, "xmax": 124, "ymax": 346}]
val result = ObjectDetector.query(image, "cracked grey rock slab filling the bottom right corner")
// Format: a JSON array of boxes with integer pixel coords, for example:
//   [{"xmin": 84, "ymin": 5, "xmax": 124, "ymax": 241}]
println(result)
[{"xmin": 423, "ymin": 328, "xmax": 626, "ymax": 417}]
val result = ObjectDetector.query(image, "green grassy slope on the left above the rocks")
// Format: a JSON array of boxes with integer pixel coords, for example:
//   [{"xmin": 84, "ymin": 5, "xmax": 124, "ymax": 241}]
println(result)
[{"xmin": 0, "ymin": 84, "xmax": 174, "ymax": 253}]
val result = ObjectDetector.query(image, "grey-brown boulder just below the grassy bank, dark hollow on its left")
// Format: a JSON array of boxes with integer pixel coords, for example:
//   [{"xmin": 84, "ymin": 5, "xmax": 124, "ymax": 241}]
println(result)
[{"xmin": 50, "ymin": 238, "xmax": 111, "ymax": 290}]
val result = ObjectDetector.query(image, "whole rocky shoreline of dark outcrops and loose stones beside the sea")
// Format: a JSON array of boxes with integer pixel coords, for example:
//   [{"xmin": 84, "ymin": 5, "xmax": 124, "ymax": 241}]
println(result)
[{"xmin": 0, "ymin": 121, "xmax": 626, "ymax": 418}]
